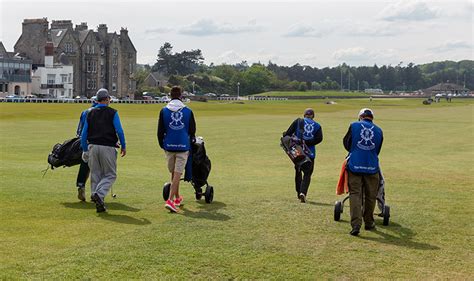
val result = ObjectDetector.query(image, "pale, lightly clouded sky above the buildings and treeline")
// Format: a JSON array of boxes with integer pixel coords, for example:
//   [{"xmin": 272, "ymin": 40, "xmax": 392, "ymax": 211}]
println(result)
[{"xmin": 0, "ymin": 0, "xmax": 474, "ymax": 68}]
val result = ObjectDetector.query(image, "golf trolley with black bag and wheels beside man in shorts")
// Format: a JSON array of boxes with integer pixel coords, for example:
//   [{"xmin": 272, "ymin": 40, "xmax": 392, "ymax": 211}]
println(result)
[{"xmin": 163, "ymin": 137, "xmax": 214, "ymax": 204}]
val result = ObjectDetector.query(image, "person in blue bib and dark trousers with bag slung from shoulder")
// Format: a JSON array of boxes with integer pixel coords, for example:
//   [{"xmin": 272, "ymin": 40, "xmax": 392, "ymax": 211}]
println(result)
[{"xmin": 283, "ymin": 108, "xmax": 323, "ymax": 203}]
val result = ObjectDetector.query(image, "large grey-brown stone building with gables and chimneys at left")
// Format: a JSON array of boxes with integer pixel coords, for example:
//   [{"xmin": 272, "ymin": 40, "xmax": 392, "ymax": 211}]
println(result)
[{"xmin": 14, "ymin": 18, "xmax": 137, "ymax": 98}]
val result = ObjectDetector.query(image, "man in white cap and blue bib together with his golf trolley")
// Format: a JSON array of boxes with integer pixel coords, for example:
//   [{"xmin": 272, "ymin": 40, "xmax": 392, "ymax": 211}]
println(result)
[{"xmin": 334, "ymin": 108, "xmax": 390, "ymax": 236}]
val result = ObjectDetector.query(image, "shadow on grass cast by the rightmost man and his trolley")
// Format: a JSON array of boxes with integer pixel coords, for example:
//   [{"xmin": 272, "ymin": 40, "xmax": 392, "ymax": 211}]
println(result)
[{"xmin": 359, "ymin": 222, "xmax": 439, "ymax": 250}]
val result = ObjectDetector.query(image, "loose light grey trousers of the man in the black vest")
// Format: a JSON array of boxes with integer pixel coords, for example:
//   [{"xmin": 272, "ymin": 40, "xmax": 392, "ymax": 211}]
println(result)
[{"xmin": 88, "ymin": 144, "xmax": 117, "ymax": 201}]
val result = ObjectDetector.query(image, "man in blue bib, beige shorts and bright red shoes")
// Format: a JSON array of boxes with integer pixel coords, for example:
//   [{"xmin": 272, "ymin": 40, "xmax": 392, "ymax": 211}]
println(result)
[{"xmin": 157, "ymin": 86, "xmax": 196, "ymax": 213}]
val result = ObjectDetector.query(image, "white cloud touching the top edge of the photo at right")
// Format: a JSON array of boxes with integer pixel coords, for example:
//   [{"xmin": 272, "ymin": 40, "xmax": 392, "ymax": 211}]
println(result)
[{"xmin": 378, "ymin": 0, "xmax": 441, "ymax": 21}]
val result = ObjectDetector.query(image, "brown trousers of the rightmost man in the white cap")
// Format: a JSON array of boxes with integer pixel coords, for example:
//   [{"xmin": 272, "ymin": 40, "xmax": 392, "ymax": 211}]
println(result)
[{"xmin": 347, "ymin": 170, "xmax": 380, "ymax": 227}]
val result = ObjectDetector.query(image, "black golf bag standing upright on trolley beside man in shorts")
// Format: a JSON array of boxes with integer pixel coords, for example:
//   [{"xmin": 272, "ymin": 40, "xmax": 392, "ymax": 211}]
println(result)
[{"xmin": 184, "ymin": 137, "xmax": 211, "ymax": 189}]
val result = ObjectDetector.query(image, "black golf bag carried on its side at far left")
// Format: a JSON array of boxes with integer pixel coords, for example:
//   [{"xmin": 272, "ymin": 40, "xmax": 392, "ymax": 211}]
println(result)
[{"xmin": 48, "ymin": 137, "xmax": 82, "ymax": 169}]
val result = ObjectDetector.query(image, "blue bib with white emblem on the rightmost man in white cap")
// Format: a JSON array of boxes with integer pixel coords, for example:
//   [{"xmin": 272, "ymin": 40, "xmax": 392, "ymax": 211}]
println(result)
[{"xmin": 344, "ymin": 119, "xmax": 383, "ymax": 174}]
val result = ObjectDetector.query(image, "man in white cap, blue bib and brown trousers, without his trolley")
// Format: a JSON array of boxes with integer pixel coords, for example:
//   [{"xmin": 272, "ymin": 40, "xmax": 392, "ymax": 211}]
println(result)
[{"xmin": 343, "ymin": 108, "xmax": 383, "ymax": 236}]
